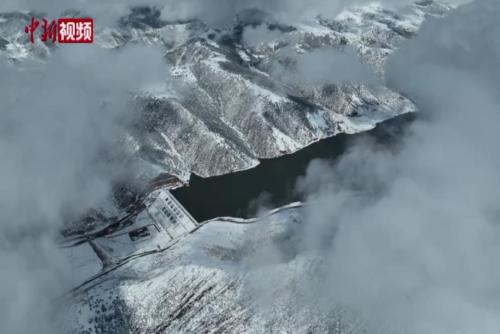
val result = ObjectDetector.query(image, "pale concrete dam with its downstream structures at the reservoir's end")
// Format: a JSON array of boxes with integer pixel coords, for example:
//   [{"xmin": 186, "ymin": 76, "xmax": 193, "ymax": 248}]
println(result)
[{"xmin": 64, "ymin": 189, "xmax": 198, "ymax": 286}]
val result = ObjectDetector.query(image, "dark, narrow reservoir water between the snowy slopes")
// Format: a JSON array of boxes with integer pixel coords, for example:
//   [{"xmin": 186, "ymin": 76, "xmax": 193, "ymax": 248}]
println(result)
[{"xmin": 172, "ymin": 114, "xmax": 415, "ymax": 221}]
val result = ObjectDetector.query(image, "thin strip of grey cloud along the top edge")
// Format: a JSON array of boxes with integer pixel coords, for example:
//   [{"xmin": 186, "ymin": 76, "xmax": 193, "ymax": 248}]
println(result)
[{"xmin": 0, "ymin": 0, "xmax": 469, "ymax": 26}]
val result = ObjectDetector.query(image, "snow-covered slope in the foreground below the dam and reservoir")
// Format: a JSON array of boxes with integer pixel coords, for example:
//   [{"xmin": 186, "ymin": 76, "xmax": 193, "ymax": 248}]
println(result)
[{"xmin": 68, "ymin": 206, "xmax": 382, "ymax": 333}]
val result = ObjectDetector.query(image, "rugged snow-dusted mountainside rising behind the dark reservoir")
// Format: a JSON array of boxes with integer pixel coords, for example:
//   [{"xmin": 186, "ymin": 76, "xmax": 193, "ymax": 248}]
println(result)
[{"xmin": 0, "ymin": 1, "xmax": 449, "ymax": 180}]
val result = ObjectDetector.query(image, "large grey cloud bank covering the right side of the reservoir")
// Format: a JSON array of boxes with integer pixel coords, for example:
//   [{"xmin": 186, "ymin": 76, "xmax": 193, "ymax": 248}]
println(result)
[{"xmin": 245, "ymin": 0, "xmax": 500, "ymax": 334}]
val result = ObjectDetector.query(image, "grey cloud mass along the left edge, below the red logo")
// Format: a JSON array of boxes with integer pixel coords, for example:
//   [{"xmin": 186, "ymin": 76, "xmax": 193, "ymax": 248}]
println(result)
[{"xmin": 0, "ymin": 46, "xmax": 166, "ymax": 334}]
